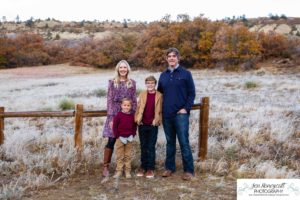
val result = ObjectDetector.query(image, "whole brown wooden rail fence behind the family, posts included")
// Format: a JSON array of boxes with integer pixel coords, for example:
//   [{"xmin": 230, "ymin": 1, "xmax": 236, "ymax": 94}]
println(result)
[{"xmin": 0, "ymin": 97, "xmax": 209, "ymax": 160}]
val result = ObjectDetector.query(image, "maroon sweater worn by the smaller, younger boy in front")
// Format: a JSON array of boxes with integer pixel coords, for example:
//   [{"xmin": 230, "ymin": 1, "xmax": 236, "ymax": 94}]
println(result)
[{"xmin": 113, "ymin": 112, "xmax": 136, "ymax": 138}]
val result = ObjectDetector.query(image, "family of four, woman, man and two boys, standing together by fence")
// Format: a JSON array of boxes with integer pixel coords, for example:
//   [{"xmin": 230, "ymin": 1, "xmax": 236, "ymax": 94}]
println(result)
[{"xmin": 102, "ymin": 48, "xmax": 195, "ymax": 180}]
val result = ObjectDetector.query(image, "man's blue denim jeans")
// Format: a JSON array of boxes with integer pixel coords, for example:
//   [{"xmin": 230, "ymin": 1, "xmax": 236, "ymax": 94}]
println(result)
[{"xmin": 163, "ymin": 114, "xmax": 194, "ymax": 174}]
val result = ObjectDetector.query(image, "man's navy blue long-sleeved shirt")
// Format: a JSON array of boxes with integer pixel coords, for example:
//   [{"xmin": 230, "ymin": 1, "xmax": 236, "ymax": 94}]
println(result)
[{"xmin": 157, "ymin": 66, "xmax": 196, "ymax": 118}]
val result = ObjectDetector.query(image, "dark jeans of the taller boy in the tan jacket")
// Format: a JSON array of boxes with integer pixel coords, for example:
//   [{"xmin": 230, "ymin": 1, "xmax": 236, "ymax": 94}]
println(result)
[{"xmin": 139, "ymin": 125, "xmax": 158, "ymax": 170}]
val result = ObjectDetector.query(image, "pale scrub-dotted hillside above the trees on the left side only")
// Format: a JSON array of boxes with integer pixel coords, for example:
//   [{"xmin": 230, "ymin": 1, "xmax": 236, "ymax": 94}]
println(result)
[{"xmin": 0, "ymin": 19, "xmax": 147, "ymax": 40}]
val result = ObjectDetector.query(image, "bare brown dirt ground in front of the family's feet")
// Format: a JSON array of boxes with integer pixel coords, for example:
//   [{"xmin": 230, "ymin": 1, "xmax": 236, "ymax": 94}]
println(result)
[{"xmin": 24, "ymin": 169, "xmax": 236, "ymax": 200}]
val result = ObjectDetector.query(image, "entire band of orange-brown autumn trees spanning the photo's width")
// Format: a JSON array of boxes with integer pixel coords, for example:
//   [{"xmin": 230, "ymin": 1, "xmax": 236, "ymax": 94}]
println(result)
[{"xmin": 0, "ymin": 16, "xmax": 300, "ymax": 70}]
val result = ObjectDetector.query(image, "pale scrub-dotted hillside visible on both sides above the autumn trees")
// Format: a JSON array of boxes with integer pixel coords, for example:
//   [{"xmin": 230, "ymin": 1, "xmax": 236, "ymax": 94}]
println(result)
[{"xmin": 0, "ymin": 17, "xmax": 300, "ymax": 40}]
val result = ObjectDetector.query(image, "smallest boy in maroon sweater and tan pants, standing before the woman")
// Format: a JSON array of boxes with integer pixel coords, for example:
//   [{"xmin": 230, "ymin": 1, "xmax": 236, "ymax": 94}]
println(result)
[{"xmin": 113, "ymin": 98, "xmax": 136, "ymax": 178}]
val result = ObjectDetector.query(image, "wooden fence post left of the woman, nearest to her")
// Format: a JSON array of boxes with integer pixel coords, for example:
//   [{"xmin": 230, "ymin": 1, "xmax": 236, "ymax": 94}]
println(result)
[{"xmin": 74, "ymin": 104, "xmax": 83, "ymax": 150}]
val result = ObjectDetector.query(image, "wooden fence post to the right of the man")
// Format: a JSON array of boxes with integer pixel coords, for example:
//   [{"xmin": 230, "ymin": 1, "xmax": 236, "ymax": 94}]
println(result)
[{"xmin": 198, "ymin": 97, "xmax": 209, "ymax": 160}]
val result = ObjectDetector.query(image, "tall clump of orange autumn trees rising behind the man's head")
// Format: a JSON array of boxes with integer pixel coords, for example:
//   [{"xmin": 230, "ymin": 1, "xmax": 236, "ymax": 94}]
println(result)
[{"xmin": 134, "ymin": 17, "xmax": 260, "ymax": 69}]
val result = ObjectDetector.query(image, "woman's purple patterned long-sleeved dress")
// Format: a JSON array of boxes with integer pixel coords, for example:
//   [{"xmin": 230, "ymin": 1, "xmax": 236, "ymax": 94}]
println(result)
[{"xmin": 103, "ymin": 79, "xmax": 137, "ymax": 138}]
